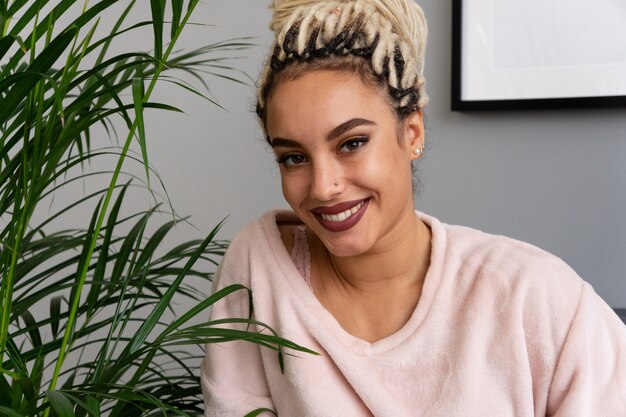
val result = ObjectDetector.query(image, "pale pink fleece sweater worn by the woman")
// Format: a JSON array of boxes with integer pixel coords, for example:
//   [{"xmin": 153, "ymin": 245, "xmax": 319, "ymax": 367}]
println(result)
[{"xmin": 202, "ymin": 212, "xmax": 626, "ymax": 417}]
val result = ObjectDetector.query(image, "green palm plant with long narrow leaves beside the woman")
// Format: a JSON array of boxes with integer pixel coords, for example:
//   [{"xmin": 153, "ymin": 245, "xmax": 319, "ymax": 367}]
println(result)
[{"xmin": 0, "ymin": 0, "xmax": 309, "ymax": 417}]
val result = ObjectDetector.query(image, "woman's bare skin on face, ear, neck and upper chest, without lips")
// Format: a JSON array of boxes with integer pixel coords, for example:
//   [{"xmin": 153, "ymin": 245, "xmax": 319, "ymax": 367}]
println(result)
[{"xmin": 266, "ymin": 70, "xmax": 431, "ymax": 342}]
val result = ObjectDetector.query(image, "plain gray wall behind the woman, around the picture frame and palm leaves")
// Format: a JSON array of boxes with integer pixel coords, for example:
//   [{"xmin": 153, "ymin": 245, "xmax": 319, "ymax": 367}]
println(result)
[{"xmin": 144, "ymin": 0, "xmax": 626, "ymax": 307}]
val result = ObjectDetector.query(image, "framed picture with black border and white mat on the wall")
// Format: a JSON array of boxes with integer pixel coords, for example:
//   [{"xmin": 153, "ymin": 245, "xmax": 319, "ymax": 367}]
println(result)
[{"xmin": 452, "ymin": 0, "xmax": 626, "ymax": 110}]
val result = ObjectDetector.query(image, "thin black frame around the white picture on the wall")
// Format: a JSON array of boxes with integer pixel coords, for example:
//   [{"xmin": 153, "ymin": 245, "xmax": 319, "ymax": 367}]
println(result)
[{"xmin": 451, "ymin": 0, "xmax": 626, "ymax": 111}]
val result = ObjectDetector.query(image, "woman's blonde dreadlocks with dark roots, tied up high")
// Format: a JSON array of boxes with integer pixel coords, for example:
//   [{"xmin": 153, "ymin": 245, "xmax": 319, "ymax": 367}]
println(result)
[{"xmin": 256, "ymin": 0, "xmax": 428, "ymax": 133}]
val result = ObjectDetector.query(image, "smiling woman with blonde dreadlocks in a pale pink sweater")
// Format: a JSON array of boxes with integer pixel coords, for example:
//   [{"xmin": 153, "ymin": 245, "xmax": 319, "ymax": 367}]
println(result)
[{"xmin": 202, "ymin": 0, "xmax": 626, "ymax": 417}]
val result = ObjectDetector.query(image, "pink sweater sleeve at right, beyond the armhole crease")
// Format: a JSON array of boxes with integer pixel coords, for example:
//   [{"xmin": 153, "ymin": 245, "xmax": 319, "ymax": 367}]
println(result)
[{"xmin": 547, "ymin": 283, "xmax": 626, "ymax": 417}]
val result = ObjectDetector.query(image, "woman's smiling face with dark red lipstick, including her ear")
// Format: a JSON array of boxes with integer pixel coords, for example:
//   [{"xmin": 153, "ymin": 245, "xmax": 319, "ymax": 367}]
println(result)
[{"xmin": 266, "ymin": 70, "xmax": 423, "ymax": 256}]
